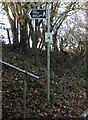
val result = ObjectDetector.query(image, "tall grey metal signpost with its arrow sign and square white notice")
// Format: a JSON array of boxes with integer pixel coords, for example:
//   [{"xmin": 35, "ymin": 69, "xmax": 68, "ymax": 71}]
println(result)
[{"xmin": 27, "ymin": 6, "xmax": 52, "ymax": 101}]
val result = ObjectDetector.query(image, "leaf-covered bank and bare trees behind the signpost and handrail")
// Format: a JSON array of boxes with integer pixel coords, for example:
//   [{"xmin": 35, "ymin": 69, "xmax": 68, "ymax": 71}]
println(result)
[{"xmin": 0, "ymin": 1, "xmax": 88, "ymax": 119}]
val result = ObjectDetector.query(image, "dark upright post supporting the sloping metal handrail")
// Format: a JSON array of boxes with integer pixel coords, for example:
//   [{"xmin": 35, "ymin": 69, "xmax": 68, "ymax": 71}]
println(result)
[{"xmin": 23, "ymin": 73, "xmax": 28, "ymax": 118}]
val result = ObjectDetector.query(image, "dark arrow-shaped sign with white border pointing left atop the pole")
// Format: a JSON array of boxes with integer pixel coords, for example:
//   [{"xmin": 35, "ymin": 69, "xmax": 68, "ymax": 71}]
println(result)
[{"xmin": 27, "ymin": 9, "xmax": 47, "ymax": 19}]
